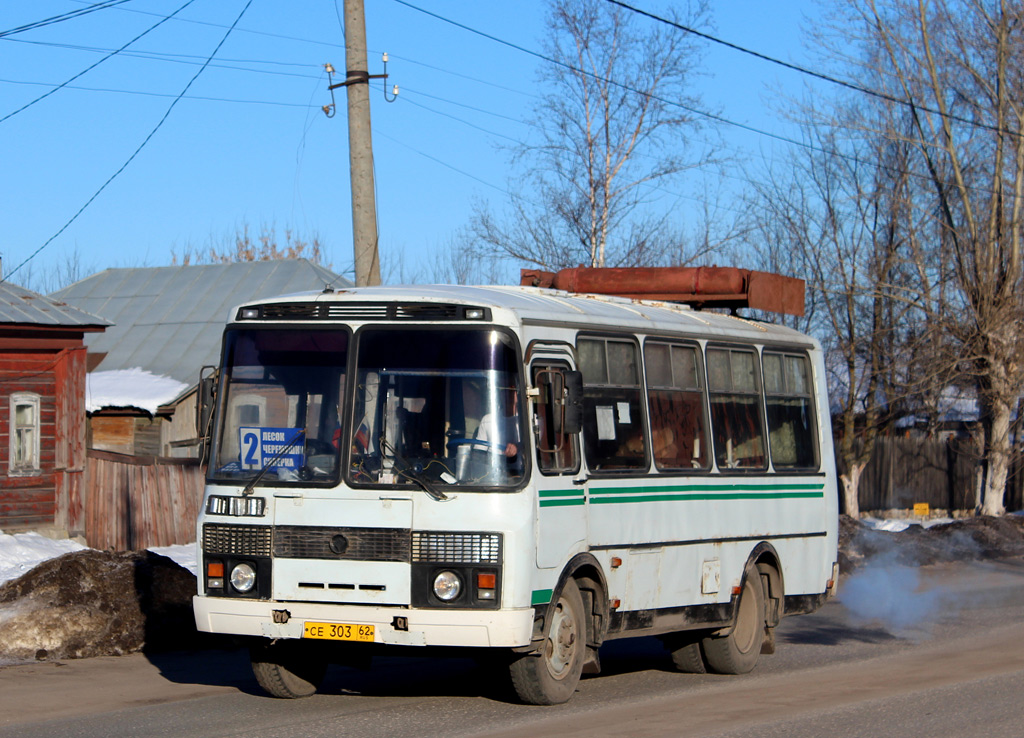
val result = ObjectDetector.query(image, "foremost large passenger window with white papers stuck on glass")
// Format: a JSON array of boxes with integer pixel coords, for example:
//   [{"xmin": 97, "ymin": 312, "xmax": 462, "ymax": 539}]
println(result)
[{"xmin": 578, "ymin": 338, "xmax": 647, "ymax": 472}]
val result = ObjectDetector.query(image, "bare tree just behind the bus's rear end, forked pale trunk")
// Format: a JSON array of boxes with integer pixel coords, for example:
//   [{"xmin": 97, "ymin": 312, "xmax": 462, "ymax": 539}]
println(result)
[{"xmin": 751, "ymin": 99, "xmax": 927, "ymax": 516}]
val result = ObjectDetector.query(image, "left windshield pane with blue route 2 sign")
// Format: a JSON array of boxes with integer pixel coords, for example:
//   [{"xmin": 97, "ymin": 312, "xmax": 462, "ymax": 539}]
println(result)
[{"xmin": 209, "ymin": 329, "xmax": 349, "ymax": 484}]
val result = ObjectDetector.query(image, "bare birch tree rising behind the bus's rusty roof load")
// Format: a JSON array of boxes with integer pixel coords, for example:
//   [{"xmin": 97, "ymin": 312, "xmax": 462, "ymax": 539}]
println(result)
[{"xmin": 472, "ymin": 0, "xmax": 708, "ymax": 268}]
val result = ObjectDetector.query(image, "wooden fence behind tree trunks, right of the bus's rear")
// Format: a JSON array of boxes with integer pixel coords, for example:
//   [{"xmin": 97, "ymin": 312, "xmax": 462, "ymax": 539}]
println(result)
[{"xmin": 837, "ymin": 438, "xmax": 1024, "ymax": 512}]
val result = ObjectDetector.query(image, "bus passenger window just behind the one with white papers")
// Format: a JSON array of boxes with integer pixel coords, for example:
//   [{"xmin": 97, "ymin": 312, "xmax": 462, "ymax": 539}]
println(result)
[{"xmin": 644, "ymin": 341, "xmax": 711, "ymax": 470}]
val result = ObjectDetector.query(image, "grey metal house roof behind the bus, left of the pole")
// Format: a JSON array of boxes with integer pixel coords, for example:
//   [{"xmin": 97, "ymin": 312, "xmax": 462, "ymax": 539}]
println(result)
[{"xmin": 51, "ymin": 259, "xmax": 351, "ymax": 386}]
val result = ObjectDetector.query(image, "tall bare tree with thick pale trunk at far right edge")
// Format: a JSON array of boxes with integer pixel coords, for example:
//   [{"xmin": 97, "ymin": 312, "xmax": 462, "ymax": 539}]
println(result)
[{"xmin": 855, "ymin": 0, "xmax": 1024, "ymax": 515}]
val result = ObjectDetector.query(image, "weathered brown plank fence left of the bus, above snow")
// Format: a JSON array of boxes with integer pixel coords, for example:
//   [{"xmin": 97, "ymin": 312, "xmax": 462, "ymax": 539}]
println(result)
[{"xmin": 85, "ymin": 449, "xmax": 204, "ymax": 551}]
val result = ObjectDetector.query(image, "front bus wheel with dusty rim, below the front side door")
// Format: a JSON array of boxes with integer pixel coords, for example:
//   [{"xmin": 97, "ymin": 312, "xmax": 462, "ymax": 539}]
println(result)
[{"xmin": 509, "ymin": 579, "xmax": 587, "ymax": 704}]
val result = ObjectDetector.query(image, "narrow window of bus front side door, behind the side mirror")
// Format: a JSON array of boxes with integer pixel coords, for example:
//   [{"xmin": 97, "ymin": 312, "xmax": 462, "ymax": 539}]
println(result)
[{"xmin": 534, "ymin": 366, "xmax": 580, "ymax": 474}]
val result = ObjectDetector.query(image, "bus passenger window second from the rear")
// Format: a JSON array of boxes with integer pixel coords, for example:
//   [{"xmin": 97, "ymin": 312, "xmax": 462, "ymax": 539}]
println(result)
[{"xmin": 707, "ymin": 348, "xmax": 767, "ymax": 469}]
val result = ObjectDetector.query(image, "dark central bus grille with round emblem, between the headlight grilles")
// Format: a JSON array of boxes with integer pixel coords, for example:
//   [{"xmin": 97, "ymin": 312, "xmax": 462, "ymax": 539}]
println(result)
[{"xmin": 273, "ymin": 525, "xmax": 410, "ymax": 561}]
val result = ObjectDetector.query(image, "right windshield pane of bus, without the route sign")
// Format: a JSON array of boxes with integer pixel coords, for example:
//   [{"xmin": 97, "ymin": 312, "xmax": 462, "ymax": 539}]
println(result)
[{"xmin": 349, "ymin": 329, "xmax": 527, "ymax": 489}]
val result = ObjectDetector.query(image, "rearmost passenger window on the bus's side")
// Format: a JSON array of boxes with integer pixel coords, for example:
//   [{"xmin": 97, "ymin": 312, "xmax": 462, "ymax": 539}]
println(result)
[{"xmin": 762, "ymin": 351, "xmax": 818, "ymax": 469}]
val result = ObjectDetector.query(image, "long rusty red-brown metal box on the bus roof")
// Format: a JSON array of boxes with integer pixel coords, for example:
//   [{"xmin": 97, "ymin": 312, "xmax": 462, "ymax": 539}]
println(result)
[{"xmin": 519, "ymin": 266, "xmax": 804, "ymax": 315}]
